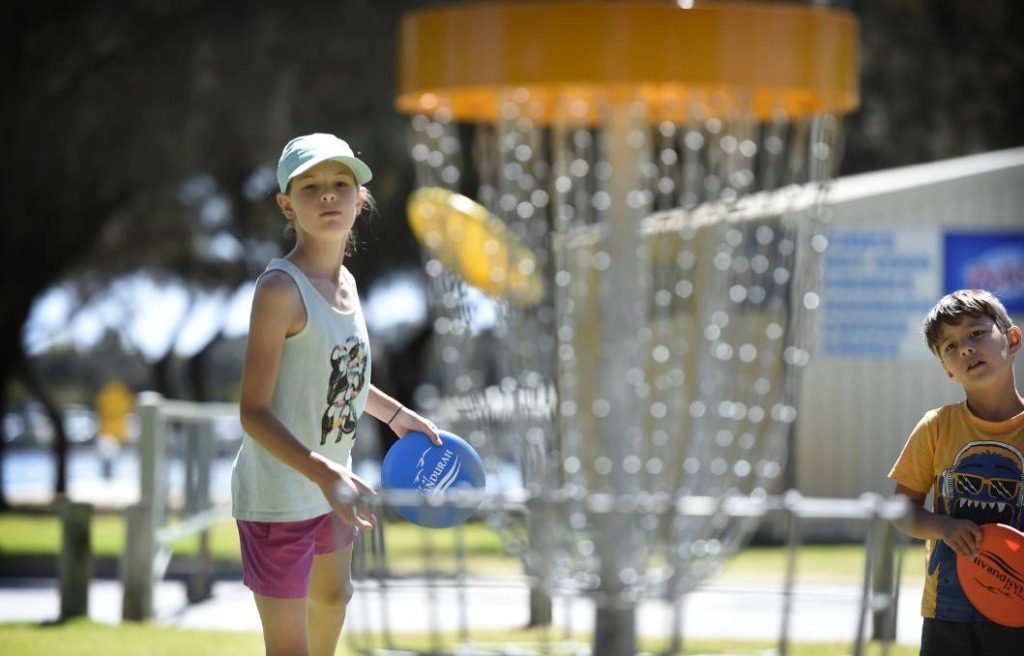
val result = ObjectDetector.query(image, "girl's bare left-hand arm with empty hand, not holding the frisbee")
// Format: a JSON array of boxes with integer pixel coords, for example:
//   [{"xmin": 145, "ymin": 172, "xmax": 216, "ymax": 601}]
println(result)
[{"xmin": 239, "ymin": 272, "xmax": 375, "ymax": 528}]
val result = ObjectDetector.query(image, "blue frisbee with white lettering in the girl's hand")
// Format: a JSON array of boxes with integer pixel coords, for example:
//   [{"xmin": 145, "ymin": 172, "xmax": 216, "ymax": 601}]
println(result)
[{"xmin": 381, "ymin": 431, "xmax": 486, "ymax": 528}]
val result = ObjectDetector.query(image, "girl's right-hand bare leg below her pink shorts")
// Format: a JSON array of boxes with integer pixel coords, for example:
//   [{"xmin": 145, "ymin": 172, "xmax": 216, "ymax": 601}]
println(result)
[{"xmin": 303, "ymin": 544, "xmax": 352, "ymax": 656}]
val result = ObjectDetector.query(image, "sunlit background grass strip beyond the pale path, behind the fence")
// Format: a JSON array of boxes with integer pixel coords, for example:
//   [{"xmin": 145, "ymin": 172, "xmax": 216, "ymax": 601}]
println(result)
[{"xmin": 0, "ymin": 513, "xmax": 925, "ymax": 581}]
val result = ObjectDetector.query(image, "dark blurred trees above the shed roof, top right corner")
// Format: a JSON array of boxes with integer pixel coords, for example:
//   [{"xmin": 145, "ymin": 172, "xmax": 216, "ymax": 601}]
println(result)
[{"xmin": 840, "ymin": 0, "xmax": 1024, "ymax": 175}]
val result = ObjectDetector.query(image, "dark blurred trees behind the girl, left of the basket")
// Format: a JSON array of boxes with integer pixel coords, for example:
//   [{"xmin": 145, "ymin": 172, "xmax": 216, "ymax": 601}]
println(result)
[{"xmin": 0, "ymin": 0, "xmax": 428, "ymax": 502}]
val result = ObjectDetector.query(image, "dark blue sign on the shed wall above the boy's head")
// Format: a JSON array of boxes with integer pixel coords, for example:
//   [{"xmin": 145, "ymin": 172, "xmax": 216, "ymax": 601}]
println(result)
[{"xmin": 945, "ymin": 232, "xmax": 1024, "ymax": 311}]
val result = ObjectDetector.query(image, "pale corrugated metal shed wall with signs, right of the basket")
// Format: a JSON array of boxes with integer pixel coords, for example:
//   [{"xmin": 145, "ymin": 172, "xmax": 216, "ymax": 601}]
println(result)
[{"xmin": 790, "ymin": 148, "xmax": 1024, "ymax": 538}]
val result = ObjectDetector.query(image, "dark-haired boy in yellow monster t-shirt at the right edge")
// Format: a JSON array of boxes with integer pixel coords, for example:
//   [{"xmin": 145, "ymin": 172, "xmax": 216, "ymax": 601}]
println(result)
[{"xmin": 889, "ymin": 290, "xmax": 1024, "ymax": 656}]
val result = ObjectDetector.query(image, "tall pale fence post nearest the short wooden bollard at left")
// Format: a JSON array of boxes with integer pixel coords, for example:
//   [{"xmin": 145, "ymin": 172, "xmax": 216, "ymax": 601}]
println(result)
[{"xmin": 121, "ymin": 392, "xmax": 167, "ymax": 620}]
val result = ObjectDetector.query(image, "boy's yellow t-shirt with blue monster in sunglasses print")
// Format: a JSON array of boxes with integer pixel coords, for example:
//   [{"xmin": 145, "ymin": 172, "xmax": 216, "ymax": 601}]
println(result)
[{"xmin": 889, "ymin": 401, "xmax": 1024, "ymax": 621}]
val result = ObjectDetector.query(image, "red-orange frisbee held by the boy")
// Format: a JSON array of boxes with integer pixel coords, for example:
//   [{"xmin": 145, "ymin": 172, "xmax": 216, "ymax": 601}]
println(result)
[{"xmin": 956, "ymin": 524, "xmax": 1024, "ymax": 627}]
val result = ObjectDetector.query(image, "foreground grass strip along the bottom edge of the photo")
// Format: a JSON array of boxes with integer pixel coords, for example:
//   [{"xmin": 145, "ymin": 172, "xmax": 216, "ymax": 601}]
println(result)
[{"xmin": 0, "ymin": 620, "xmax": 918, "ymax": 656}]
